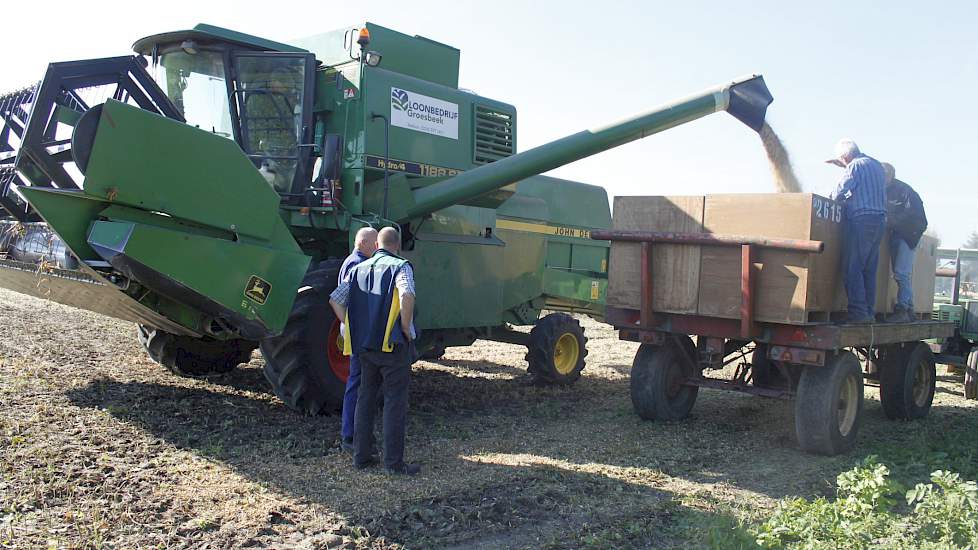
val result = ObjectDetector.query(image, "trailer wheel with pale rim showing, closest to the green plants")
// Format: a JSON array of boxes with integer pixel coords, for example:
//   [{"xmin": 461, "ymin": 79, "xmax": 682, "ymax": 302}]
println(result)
[{"xmin": 795, "ymin": 351, "xmax": 863, "ymax": 455}]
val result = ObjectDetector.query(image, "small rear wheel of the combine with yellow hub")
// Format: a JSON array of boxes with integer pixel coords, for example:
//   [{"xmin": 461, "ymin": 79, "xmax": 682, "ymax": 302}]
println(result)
[{"xmin": 526, "ymin": 313, "xmax": 587, "ymax": 385}]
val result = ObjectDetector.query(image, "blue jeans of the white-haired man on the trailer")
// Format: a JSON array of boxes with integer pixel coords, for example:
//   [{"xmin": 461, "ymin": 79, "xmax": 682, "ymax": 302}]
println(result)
[{"xmin": 842, "ymin": 214, "xmax": 886, "ymax": 320}]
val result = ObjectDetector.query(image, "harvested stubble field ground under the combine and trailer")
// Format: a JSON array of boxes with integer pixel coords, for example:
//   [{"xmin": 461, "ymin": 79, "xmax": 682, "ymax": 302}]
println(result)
[{"xmin": 0, "ymin": 290, "xmax": 978, "ymax": 549}]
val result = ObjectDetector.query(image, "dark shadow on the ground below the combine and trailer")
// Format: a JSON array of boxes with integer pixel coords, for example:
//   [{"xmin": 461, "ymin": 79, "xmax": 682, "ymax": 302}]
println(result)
[{"xmin": 68, "ymin": 360, "xmax": 978, "ymax": 548}]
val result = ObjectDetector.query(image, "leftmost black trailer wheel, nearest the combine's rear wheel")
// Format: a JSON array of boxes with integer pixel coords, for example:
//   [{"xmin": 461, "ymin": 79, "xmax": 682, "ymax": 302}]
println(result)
[{"xmin": 629, "ymin": 336, "xmax": 699, "ymax": 420}]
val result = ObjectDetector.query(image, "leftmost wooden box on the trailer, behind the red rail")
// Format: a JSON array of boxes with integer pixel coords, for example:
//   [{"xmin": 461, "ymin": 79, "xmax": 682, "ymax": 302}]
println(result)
[{"xmin": 608, "ymin": 196, "xmax": 704, "ymax": 314}]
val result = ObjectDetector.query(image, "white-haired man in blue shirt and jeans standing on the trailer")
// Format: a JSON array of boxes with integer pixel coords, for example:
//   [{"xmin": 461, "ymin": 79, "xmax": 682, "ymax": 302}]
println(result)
[{"xmin": 826, "ymin": 139, "xmax": 886, "ymax": 324}]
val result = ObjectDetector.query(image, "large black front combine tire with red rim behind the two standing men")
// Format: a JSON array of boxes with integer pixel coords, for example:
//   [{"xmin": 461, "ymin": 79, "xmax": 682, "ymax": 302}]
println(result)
[{"xmin": 261, "ymin": 260, "xmax": 350, "ymax": 415}]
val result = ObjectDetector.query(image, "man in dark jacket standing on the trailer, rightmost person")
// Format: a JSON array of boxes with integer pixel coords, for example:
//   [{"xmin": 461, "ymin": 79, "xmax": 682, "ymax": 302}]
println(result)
[{"xmin": 883, "ymin": 163, "xmax": 927, "ymax": 323}]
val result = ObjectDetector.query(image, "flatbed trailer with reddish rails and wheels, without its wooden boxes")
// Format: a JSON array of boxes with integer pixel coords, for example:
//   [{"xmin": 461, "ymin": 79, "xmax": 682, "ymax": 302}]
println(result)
[{"xmin": 591, "ymin": 230, "xmax": 954, "ymax": 455}]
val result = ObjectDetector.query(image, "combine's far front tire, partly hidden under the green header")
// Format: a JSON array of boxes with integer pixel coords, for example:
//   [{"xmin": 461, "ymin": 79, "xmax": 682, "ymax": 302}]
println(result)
[{"xmin": 137, "ymin": 325, "xmax": 258, "ymax": 377}]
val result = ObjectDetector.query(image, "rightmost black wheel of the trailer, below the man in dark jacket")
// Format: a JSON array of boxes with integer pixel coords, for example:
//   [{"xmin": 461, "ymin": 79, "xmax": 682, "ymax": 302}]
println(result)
[{"xmin": 879, "ymin": 342, "xmax": 937, "ymax": 420}]
